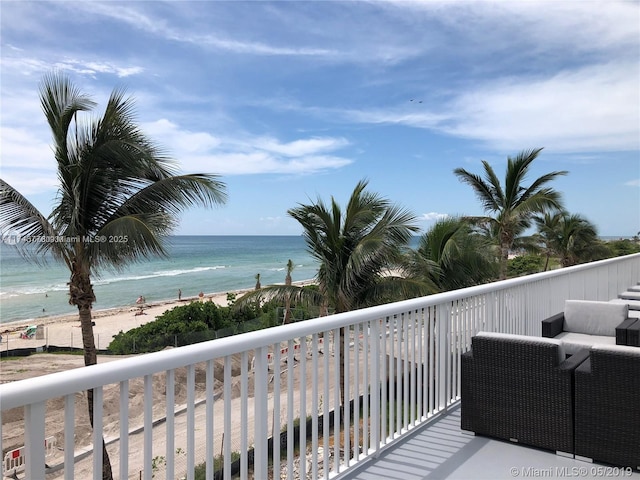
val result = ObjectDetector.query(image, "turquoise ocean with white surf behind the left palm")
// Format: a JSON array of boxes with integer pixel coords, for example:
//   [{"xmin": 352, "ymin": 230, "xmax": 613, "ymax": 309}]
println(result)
[{"xmin": 0, "ymin": 236, "xmax": 318, "ymax": 323}]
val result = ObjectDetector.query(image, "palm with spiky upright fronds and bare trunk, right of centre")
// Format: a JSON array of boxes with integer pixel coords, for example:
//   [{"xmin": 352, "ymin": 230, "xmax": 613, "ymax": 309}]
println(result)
[{"xmin": 453, "ymin": 148, "xmax": 568, "ymax": 279}]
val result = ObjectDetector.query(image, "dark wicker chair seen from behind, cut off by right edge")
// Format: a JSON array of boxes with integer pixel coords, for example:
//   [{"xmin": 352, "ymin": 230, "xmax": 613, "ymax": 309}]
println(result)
[{"xmin": 575, "ymin": 345, "xmax": 640, "ymax": 469}]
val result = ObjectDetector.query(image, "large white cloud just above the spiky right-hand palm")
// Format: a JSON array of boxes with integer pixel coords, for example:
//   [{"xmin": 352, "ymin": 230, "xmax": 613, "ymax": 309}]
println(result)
[{"xmin": 444, "ymin": 64, "xmax": 640, "ymax": 152}]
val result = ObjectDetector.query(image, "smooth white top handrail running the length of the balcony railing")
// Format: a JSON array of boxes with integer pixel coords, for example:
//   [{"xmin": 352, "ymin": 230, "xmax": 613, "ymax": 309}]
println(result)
[{"xmin": 0, "ymin": 253, "xmax": 640, "ymax": 410}]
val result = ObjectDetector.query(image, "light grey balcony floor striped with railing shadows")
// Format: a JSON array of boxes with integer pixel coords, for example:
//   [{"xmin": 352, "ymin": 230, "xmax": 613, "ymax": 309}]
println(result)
[{"xmin": 343, "ymin": 406, "xmax": 640, "ymax": 480}]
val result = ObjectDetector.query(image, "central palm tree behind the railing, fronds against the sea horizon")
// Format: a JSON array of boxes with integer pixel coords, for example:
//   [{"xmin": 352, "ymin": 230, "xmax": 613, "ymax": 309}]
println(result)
[{"xmin": 241, "ymin": 180, "xmax": 430, "ymax": 407}]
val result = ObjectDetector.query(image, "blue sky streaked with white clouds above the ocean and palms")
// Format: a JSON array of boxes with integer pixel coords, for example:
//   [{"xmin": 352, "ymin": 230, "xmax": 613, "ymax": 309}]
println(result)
[{"xmin": 0, "ymin": 0, "xmax": 640, "ymax": 236}]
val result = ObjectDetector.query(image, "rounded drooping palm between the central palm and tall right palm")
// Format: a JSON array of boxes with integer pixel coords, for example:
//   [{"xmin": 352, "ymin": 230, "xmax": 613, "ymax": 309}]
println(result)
[{"xmin": 408, "ymin": 217, "xmax": 497, "ymax": 291}]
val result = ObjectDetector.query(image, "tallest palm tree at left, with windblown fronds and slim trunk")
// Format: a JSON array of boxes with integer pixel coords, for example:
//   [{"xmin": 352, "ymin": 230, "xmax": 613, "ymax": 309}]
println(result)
[{"xmin": 0, "ymin": 73, "xmax": 226, "ymax": 479}]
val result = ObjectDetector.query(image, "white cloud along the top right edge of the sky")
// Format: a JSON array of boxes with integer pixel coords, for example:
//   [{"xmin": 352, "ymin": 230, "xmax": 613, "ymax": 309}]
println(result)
[{"xmin": 380, "ymin": 0, "xmax": 638, "ymax": 52}]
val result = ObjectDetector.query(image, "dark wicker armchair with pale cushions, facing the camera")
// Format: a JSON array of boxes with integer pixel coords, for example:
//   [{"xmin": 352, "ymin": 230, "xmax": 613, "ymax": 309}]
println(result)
[{"xmin": 542, "ymin": 300, "xmax": 629, "ymax": 355}]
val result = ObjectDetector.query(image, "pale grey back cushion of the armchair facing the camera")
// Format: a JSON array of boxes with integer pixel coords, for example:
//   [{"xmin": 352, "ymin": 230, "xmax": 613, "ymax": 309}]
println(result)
[{"xmin": 562, "ymin": 300, "xmax": 629, "ymax": 336}]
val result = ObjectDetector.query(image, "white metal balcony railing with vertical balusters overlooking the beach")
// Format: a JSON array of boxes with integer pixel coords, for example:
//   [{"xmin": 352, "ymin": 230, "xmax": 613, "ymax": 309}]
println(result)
[{"xmin": 0, "ymin": 254, "xmax": 640, "ymax": 479}]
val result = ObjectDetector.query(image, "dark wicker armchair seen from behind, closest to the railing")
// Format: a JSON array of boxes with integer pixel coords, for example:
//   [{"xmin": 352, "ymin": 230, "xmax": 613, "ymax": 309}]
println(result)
[{"xmin": 461, "ymin": 332, "xmax": 589, "ymax": 455}]
